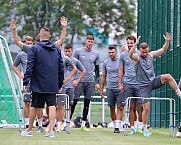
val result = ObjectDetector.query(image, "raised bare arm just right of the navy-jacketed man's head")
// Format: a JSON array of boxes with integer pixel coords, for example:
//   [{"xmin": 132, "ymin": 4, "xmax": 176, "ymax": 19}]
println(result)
[{"xmin": 55, "ymin": 17, "xmax": 67, "ymax": 47}]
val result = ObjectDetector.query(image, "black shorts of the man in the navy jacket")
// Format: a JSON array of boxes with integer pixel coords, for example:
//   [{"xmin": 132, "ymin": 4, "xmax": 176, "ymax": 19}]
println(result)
[{"xmin": 31, "ymin": 92, "xmax": 56, "ymax": 108}]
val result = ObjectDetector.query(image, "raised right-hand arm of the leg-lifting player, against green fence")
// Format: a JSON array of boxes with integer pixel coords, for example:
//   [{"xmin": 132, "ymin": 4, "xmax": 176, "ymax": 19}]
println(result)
[{"xmin": 150, "ymin": 32, "xmax": 170, "ymax": 58}]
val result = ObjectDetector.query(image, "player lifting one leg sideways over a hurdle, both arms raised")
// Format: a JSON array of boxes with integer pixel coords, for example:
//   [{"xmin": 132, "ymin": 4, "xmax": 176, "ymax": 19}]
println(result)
[{"xmin": 129, "ymin": 32, "xmax": 181, "ymax": 136}]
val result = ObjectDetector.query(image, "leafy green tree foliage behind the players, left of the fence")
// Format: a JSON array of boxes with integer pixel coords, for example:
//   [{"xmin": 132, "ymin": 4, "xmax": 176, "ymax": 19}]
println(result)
[{"xmin": 0, "ymin": 0, "xmax": 136, "ymax": 43}]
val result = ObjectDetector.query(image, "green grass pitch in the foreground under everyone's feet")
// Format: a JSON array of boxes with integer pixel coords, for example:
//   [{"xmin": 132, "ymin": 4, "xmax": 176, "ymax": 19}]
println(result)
[{"xmin": 0, "ymin": 128, "xmax": 181, "ymax": 145}]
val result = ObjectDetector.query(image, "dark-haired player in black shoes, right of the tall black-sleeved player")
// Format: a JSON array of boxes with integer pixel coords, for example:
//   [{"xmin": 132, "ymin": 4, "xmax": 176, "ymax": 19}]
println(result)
[{"xmin": 100, "ymin": 46, "xmax": 125, "ymax": 133}]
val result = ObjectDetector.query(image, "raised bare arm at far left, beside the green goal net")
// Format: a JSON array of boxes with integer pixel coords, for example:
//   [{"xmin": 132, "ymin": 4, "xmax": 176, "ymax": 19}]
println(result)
[{"xmin": 10, "ymin": 20, "xmax": 24, "ymax": 49}]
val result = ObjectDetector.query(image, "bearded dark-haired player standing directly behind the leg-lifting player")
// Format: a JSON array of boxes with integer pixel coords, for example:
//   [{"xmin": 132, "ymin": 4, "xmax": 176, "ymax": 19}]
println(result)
[{"xmin": 119, "ymin": 35, "xmax": 143, "ymax": 134}]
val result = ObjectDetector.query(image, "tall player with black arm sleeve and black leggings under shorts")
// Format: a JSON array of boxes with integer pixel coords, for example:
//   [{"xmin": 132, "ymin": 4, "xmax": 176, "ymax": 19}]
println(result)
[{"xmin": 71, "ymin": 35, "xmax": 100, "ymax": 131}]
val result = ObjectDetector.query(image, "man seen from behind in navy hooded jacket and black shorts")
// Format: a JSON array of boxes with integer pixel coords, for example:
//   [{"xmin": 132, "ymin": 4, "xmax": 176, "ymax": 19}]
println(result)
[{"xmin": 21, "ymin": 27, "xmax": 64, "ymax": 137}]
